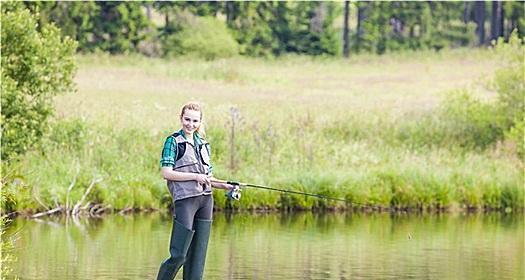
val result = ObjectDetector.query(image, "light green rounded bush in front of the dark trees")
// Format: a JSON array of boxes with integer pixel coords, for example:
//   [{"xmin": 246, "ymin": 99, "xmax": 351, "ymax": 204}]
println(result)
[{"xmin": 163, "ymin": 13, "xmax": 239, "ymax": 60}]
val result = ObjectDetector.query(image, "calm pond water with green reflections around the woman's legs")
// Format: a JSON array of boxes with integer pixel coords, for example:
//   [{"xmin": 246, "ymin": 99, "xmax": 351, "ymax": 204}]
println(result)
[{"xmin": 8, "ymin": 212, "xmax": 525, "ymax": 280}]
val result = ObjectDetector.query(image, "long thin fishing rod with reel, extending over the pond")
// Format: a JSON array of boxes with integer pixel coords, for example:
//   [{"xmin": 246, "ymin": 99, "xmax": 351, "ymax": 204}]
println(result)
[{"xmin": 213, "ymin": 180, "xmax": 392, "ymax": 211}]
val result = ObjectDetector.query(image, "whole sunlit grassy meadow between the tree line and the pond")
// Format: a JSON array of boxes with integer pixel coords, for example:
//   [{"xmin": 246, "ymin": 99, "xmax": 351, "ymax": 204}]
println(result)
[{"xmin": 9, "ymin": 49, "xmax": 524, "ymax": 213}]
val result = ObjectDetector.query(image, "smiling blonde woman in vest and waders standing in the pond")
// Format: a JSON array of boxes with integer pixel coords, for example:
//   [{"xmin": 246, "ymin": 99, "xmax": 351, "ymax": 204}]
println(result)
[{"xmin": 157, "ymin": 103, "xmax": 232, "ymax": 280}]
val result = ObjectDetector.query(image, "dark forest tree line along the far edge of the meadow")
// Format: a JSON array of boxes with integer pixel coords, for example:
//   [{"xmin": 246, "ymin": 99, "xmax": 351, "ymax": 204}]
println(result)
[{"xmin": 25, "ymin": 1, "xmax": 525, "ymax": 56}]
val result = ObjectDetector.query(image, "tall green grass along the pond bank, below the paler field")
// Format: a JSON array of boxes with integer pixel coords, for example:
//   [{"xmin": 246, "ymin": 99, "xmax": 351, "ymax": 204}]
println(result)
[{"xmin": 3, "ymin": 108, "xmax": 524, "ymax": 213}]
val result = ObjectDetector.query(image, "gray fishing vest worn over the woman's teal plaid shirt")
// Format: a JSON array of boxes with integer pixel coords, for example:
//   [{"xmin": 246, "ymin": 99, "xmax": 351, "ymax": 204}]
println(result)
[{"xmin": 168, "ymin": 133, "xmax": 211, "ymax": 201}]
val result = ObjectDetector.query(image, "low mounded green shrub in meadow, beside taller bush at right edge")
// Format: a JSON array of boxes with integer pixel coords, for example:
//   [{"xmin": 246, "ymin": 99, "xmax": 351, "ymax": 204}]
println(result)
[{"xmin": 387, "ymin": 90, "xmax": 504, "ymax": 149}]
